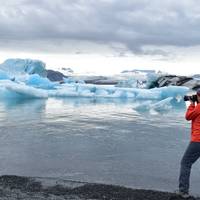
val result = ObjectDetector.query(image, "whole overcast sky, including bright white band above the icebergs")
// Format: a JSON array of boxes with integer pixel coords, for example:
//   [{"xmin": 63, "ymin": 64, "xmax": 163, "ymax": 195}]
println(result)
[{"xmin": 0, "ymin": 0, "xmax": 200, "ymax": 74}]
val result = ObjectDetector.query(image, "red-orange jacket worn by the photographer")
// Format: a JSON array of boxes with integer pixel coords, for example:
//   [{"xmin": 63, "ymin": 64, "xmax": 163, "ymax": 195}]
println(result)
[{"xmin": 185, "ymin": 103, "xmax": 200, "ymax": 142}]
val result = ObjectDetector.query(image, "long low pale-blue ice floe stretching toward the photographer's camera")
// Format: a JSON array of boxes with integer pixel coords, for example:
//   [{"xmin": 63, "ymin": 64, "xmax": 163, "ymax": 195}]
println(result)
[{"xmin": 49, "ymin": 84, "xmax": 188, "ymax": 100}]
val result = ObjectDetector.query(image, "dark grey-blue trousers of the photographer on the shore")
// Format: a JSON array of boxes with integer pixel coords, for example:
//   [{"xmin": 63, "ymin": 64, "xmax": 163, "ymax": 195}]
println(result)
[{"xmin": 179, "ymin": 142, "xmax": 200, "ymax": 193}]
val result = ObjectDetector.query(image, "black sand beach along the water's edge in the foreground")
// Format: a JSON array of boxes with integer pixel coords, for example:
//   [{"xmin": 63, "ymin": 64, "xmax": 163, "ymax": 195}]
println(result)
[{"xmin": 0, "ymin": 175, "xmax": 198, "ymax": 200}]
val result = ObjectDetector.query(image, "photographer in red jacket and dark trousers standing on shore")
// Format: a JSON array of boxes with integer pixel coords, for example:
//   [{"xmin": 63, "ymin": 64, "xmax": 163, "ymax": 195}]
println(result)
[{"xmin": 179, "ymin": 89, "xmax": 200, "ymax": 198}]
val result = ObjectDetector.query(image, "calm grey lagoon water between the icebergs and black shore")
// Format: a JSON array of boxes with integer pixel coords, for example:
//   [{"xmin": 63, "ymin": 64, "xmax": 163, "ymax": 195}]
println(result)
[{"xmin": 0, "ymin": 98, "xmax": 200, "ymax": 194}]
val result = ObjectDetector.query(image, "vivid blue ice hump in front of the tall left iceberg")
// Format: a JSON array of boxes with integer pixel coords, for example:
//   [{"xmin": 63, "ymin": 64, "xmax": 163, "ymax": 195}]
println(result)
[{"xmin": 26, "ymin": 74, "xmax": 58, "ymax": 89}]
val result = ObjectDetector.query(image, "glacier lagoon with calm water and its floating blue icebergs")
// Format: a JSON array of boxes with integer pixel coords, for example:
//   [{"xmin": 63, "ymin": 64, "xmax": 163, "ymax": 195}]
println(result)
[{"xmin": 0, "ymin": 59, "xmax": 200, "ymax": 193}]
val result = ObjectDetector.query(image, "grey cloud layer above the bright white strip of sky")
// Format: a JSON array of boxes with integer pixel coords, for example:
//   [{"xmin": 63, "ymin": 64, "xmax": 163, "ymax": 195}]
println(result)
[{"xmin": 0, "ymin": 0, "xmax": 200, "ymax": 55}]
